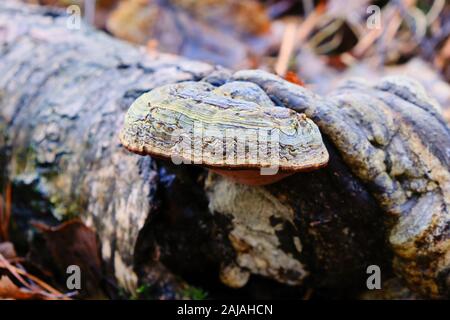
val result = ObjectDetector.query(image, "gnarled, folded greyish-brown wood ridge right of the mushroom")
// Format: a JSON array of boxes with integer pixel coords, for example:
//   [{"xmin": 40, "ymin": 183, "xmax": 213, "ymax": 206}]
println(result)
[{"xmin": 235, "ymin": 71, "xmax": 450, "ymax": 297}]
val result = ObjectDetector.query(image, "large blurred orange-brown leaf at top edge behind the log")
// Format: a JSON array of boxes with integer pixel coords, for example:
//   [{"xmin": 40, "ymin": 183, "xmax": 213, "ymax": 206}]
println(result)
[{"xmin": 106, "ymin": 0, "xmax": 279, "ymax": 69}]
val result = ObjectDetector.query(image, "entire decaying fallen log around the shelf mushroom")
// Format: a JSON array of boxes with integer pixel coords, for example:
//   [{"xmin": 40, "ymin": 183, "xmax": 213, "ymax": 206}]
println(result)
[{"xmin": 0, "ymin": 1, "xmax": 450, "ymax": 297}]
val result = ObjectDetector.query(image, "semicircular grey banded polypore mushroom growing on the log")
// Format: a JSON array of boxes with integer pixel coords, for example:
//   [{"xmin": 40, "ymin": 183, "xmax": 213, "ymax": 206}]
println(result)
[{"xmin": 120, "ymin": 81, "xmax": 328, "ymax": 185}]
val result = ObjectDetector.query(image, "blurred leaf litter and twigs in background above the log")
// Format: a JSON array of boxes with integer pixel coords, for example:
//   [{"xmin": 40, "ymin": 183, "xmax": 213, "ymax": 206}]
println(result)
[{"xmin": 23, "ymin": 0, "xmax": 450, "ymax": 111}]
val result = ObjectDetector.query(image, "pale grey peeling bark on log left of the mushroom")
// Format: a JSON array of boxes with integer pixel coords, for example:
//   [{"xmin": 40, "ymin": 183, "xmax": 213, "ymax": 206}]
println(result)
[{"xmin": 0, "ymin": 1, "xmax": 217, "ymax": 290}]
